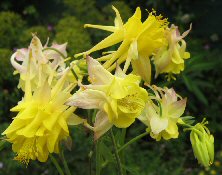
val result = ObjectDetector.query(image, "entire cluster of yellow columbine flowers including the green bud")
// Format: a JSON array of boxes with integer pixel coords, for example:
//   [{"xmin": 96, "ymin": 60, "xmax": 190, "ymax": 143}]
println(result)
[{"xmin": 3, "ymin": 7, "xmax": 214, "ymax": 166}]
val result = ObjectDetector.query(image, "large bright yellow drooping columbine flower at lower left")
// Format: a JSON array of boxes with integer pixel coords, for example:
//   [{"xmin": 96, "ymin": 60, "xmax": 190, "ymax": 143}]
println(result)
[{"xmin": 2, "ymin": 70, "xmax": 75, "ymax": 164}]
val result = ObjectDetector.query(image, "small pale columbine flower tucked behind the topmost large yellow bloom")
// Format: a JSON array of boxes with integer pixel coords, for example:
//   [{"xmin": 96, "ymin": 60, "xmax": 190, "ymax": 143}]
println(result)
[{"xmin": 153, "ymin": 25, "xmax": 191, "ymax": 77}]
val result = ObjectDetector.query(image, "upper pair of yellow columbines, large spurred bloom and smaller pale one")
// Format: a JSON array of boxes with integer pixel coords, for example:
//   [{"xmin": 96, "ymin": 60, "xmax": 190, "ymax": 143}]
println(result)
[{"xmin": 75, "ymin": 7, "xmax": 190, "ymax": 83}]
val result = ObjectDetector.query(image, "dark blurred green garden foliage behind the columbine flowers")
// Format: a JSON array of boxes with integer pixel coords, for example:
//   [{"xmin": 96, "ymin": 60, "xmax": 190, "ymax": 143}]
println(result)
[{"xmin": 0, "ymin": 0, "xmax": 222, "ymax": 175}]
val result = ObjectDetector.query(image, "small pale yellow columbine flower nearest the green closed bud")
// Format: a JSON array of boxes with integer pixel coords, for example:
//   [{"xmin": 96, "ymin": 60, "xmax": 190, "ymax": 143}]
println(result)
[{"xmin": 139, "ymin": 86, "xmax": 186, "ymax": 141}]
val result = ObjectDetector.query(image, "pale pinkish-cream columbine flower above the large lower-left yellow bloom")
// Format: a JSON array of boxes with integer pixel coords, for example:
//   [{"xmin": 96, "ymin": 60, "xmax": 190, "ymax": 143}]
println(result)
[{"xmin": 11, "ymin": 35, "xmax": 67, "ymax": 91}]
